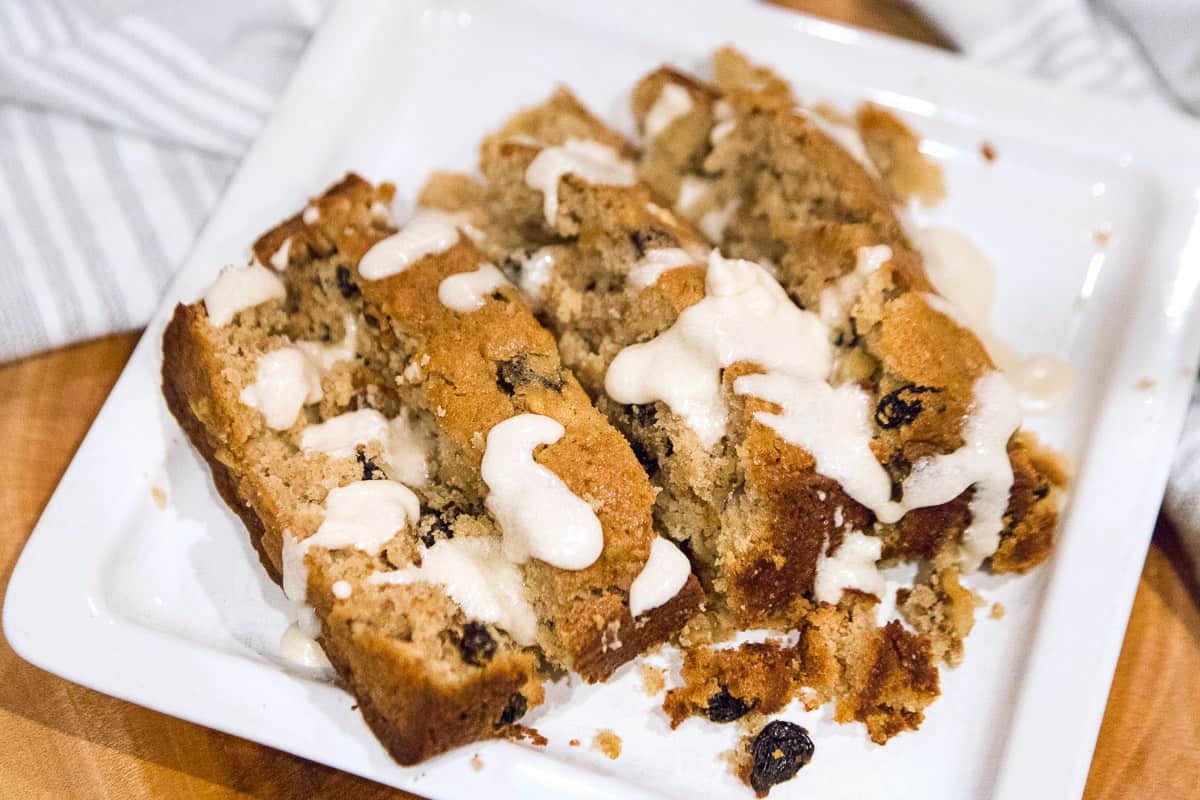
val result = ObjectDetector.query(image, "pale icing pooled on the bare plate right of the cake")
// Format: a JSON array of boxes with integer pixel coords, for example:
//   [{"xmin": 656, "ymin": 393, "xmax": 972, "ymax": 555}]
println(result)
[{"xmin": 917, "ymin": 228, "xmax": 1072, "ymax": 414}]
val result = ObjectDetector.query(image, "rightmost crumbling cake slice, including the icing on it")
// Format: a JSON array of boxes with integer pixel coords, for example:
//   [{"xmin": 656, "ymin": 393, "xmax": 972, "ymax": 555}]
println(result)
[{"xmin": 632, "ymin": 50, "xmax": 1066, "ymax": 662}]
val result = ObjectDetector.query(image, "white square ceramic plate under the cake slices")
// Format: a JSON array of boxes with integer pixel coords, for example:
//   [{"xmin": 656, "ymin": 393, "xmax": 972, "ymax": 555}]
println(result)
[{"xmin": 4, "ymin": 0, "xmax": 1200, "ymax": 800}]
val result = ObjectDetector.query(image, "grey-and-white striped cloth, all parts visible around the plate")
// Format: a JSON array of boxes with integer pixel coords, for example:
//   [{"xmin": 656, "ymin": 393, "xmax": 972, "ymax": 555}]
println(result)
[{"xmin": 0, "ymin": 0, "xmax": 1200, "ymax": 573}]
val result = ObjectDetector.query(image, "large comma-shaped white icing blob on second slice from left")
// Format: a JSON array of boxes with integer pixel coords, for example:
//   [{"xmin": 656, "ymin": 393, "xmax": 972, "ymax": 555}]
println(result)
[{"xmin": 480, "ymin": 414, "xmax": 604, "ymax": 570}]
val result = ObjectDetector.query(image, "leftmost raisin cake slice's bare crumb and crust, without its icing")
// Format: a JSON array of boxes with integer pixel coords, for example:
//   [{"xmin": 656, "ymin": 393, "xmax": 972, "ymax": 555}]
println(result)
[{"xmin": 162, "ymin": 176, "xmax": 544, "ymax": 764}]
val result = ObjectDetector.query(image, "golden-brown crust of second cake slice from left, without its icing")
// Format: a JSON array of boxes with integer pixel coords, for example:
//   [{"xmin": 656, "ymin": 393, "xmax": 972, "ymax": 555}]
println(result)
[{"xmin": 336, "ymin": 195, "xmax": 703, "ymax": 681}]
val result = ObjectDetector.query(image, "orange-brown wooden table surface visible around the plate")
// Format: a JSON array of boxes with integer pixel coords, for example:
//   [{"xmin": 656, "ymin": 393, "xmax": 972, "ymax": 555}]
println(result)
[{"xmin": 0, "ymin": 0, "xmax": 1200, "ymax": 800}]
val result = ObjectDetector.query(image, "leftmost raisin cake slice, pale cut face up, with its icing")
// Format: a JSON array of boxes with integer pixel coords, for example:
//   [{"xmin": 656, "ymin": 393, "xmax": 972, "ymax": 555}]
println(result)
[{"xmin": 162, "ymin": 178, "xmax": 542, "ymax": 764}]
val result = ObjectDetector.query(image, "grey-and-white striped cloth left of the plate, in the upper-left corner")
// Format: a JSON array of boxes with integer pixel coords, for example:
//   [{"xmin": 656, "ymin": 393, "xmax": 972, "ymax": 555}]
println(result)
[{"xmin": 0, "ymin": 0, "xmax": 323, "ymax": 361}]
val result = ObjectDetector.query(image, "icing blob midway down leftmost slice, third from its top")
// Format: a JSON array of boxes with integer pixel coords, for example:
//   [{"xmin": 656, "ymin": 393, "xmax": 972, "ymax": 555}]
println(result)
[{"xmin": 300, "ymin": 408, "xmax": 427, "ymax": 486}]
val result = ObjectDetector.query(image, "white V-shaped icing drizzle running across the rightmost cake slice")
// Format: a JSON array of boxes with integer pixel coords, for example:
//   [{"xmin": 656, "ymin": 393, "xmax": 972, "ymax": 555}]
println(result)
[{"xmin": 734, "ymin": 372, "xmax": 1021, "ymax": 572}]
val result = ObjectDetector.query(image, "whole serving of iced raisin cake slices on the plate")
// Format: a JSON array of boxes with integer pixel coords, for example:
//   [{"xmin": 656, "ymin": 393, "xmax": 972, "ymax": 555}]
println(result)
[{"xmin": 163, "ymin": 50, "xmax": 1066, "ymax": 795}]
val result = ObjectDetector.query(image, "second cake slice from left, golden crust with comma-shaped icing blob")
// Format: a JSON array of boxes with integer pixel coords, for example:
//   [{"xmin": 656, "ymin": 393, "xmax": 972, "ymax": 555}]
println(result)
[{"xmin": 352, "ymin": 196, "xmax": 703, "ymax": 681}]
